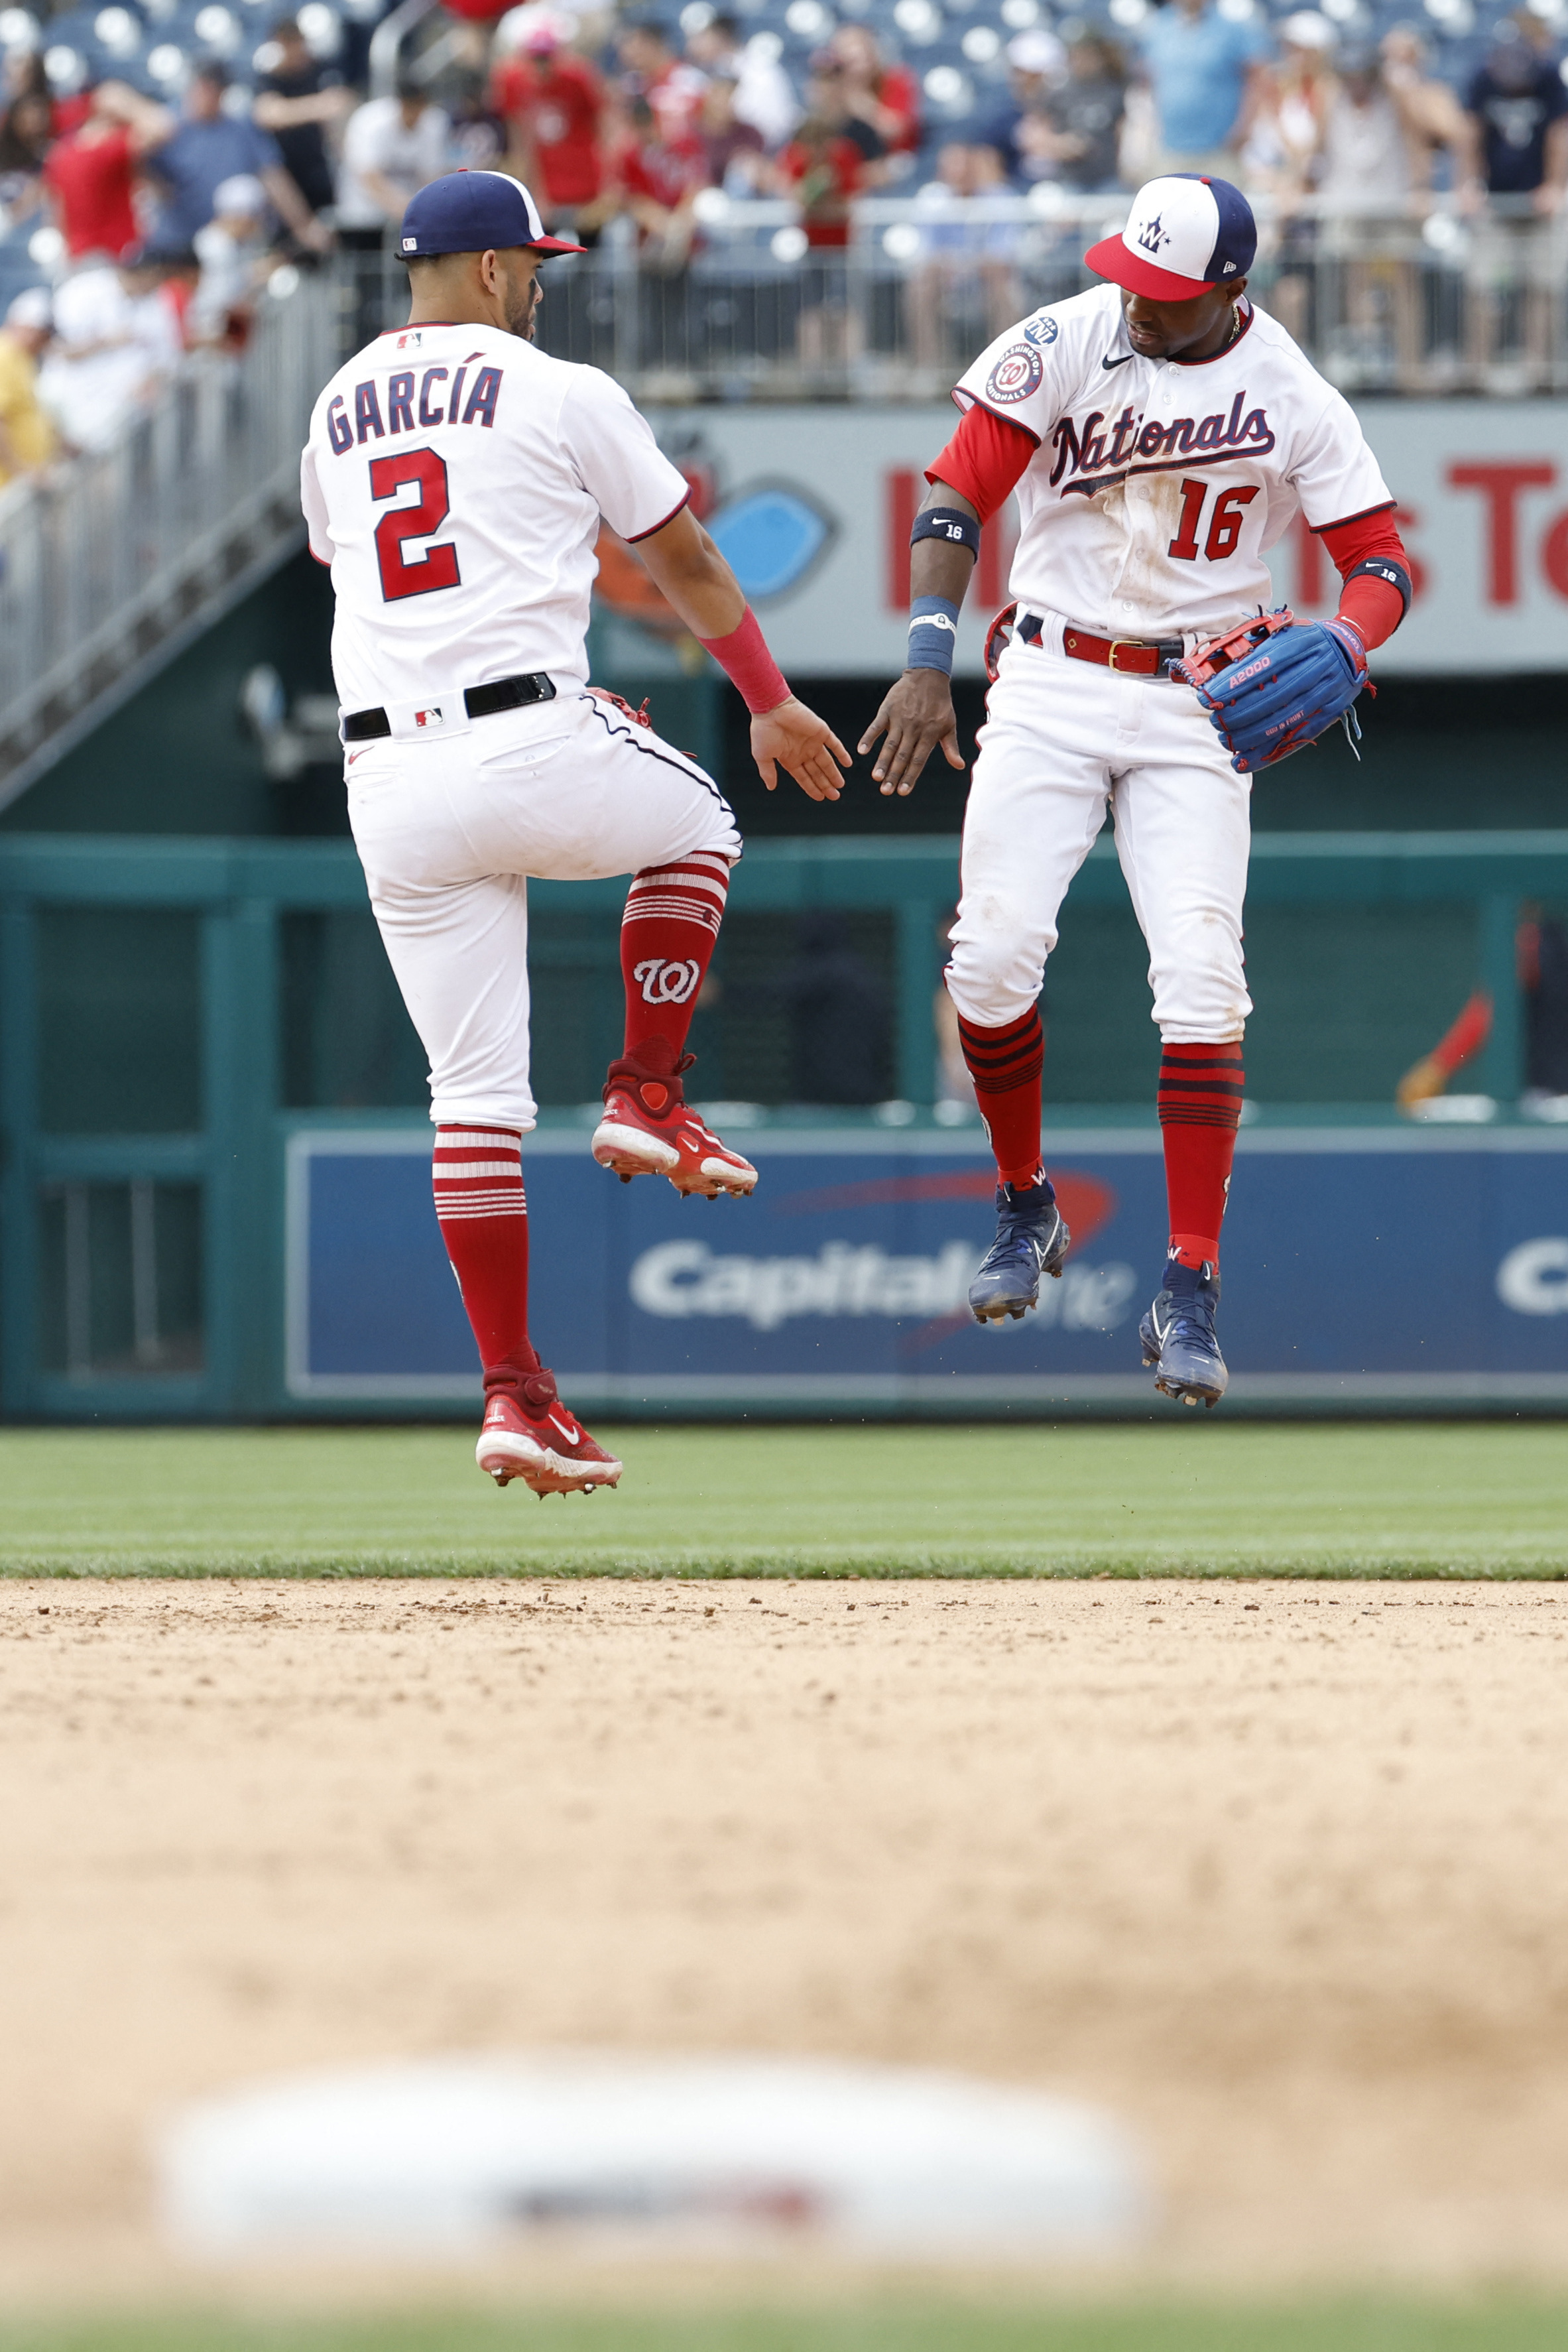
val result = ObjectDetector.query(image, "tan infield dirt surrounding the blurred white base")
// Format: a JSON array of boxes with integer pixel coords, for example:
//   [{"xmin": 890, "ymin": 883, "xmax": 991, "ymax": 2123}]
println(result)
[{"xmin": 0, "ymin": 1581, "xmax": 1568, "ymax": 2298}]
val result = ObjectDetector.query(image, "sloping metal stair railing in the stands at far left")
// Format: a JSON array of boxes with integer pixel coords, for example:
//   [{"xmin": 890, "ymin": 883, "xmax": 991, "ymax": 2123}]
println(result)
[{"xmin": 0, "ymin": 273, "xmax": 341, "ymax": 807}]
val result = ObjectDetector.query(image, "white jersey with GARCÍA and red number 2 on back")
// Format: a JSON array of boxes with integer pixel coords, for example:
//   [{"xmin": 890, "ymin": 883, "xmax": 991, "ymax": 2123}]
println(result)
[{"xmin": 301, "ymin": 324, "xmax": 689, "ymax": 710}]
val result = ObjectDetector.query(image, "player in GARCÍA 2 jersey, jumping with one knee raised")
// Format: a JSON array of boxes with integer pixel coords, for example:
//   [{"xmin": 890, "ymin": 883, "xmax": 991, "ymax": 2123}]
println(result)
[{"xmin": 301, "ymin": 172, "xmax": 849, "ymax": 1496}]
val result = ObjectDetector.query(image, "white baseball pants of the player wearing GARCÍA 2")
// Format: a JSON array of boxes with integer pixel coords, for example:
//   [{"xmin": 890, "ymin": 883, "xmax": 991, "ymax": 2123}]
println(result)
[{"xmin": 345, "ymin": 689, "xmax": 741, "ymax": 1129}]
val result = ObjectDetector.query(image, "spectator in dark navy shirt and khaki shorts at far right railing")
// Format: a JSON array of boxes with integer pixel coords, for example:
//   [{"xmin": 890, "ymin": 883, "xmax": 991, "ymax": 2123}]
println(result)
[{"xmin": 1462, "ymin": 26, "xmax": 1568, "ymax": 386}]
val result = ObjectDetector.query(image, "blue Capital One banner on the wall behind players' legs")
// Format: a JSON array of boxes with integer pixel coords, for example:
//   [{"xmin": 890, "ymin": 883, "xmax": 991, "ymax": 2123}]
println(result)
[{"xmin": 287, "ymin": 1127, "xmax": 1568, "ymax": 1416}]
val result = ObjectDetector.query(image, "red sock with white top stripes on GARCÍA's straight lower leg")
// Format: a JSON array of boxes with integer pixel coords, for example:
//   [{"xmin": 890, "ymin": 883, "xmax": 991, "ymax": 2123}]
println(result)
[{"xmin": 430, "ymin": 1127, "xmax": 538, "ymax": 1397}]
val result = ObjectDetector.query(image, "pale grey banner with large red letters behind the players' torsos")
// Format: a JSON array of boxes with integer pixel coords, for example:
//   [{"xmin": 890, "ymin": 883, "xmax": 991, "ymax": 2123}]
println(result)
[{"xmin": 634, "ymin": 400, "xmax": 1568, "ymax": 680}]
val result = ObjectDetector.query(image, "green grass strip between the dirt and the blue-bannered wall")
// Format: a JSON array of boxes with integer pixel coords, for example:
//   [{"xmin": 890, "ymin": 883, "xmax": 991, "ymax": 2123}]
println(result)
[{"xmin": 0, "ymin": 1418, "xmax": 1568, "ymax": 1578}]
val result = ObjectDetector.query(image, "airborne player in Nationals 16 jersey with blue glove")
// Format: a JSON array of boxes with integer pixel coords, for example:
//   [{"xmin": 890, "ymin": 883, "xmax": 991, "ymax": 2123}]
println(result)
[{"xmin": 861, "ymin": 172, "xmax": 1410, "ymax": 1404}]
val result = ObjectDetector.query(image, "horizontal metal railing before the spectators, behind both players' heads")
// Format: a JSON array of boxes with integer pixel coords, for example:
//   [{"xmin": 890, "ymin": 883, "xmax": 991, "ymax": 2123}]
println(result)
[{"xmin": 341, "ymin": 184, "xmax": 1568, "ymax": 400}]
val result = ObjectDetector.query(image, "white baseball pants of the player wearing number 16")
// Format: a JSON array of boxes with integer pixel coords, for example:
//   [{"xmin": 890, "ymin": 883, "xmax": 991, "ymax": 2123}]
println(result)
[{"xmin": 947, "ymin": 614, "xmax": 1253, "ymax": 1044}]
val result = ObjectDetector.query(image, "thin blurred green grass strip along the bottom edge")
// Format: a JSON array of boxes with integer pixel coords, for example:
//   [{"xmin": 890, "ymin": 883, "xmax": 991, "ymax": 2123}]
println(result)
[{"xmin": 0, "ymin": 2300, "xmax": 1568, "ymax": 2352}]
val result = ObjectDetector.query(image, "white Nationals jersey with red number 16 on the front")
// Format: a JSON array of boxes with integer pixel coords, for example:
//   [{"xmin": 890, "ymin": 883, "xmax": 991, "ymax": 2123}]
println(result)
[{"xmin": 955, "ymin": 284, "xmax": 1394, "ymax": 637}]
